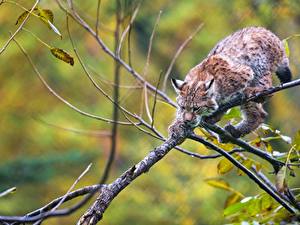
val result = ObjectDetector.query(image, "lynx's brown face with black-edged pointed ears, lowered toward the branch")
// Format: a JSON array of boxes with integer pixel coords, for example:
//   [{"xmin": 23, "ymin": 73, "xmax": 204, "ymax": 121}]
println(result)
[{"xmin": 171, "ymin": 77, "xmax": 218, "ymax": 127}]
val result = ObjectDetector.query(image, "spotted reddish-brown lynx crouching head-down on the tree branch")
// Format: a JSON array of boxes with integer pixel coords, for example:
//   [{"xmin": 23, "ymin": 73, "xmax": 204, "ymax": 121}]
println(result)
[{"xmin": 171, "ymin": 27, "xmax": 291, "ymax": 138}]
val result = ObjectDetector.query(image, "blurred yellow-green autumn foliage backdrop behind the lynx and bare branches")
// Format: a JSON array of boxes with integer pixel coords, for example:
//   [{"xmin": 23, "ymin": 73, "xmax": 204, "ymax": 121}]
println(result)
[{"xmin": 0, "ymin": 0, "xmax": 300, "ymax": 225}]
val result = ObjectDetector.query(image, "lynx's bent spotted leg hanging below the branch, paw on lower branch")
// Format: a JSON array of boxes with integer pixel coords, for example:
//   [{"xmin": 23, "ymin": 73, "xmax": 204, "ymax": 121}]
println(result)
[{"xmin": 225, "ymin": 102, "xmax": 267, "ymax": 138}]
